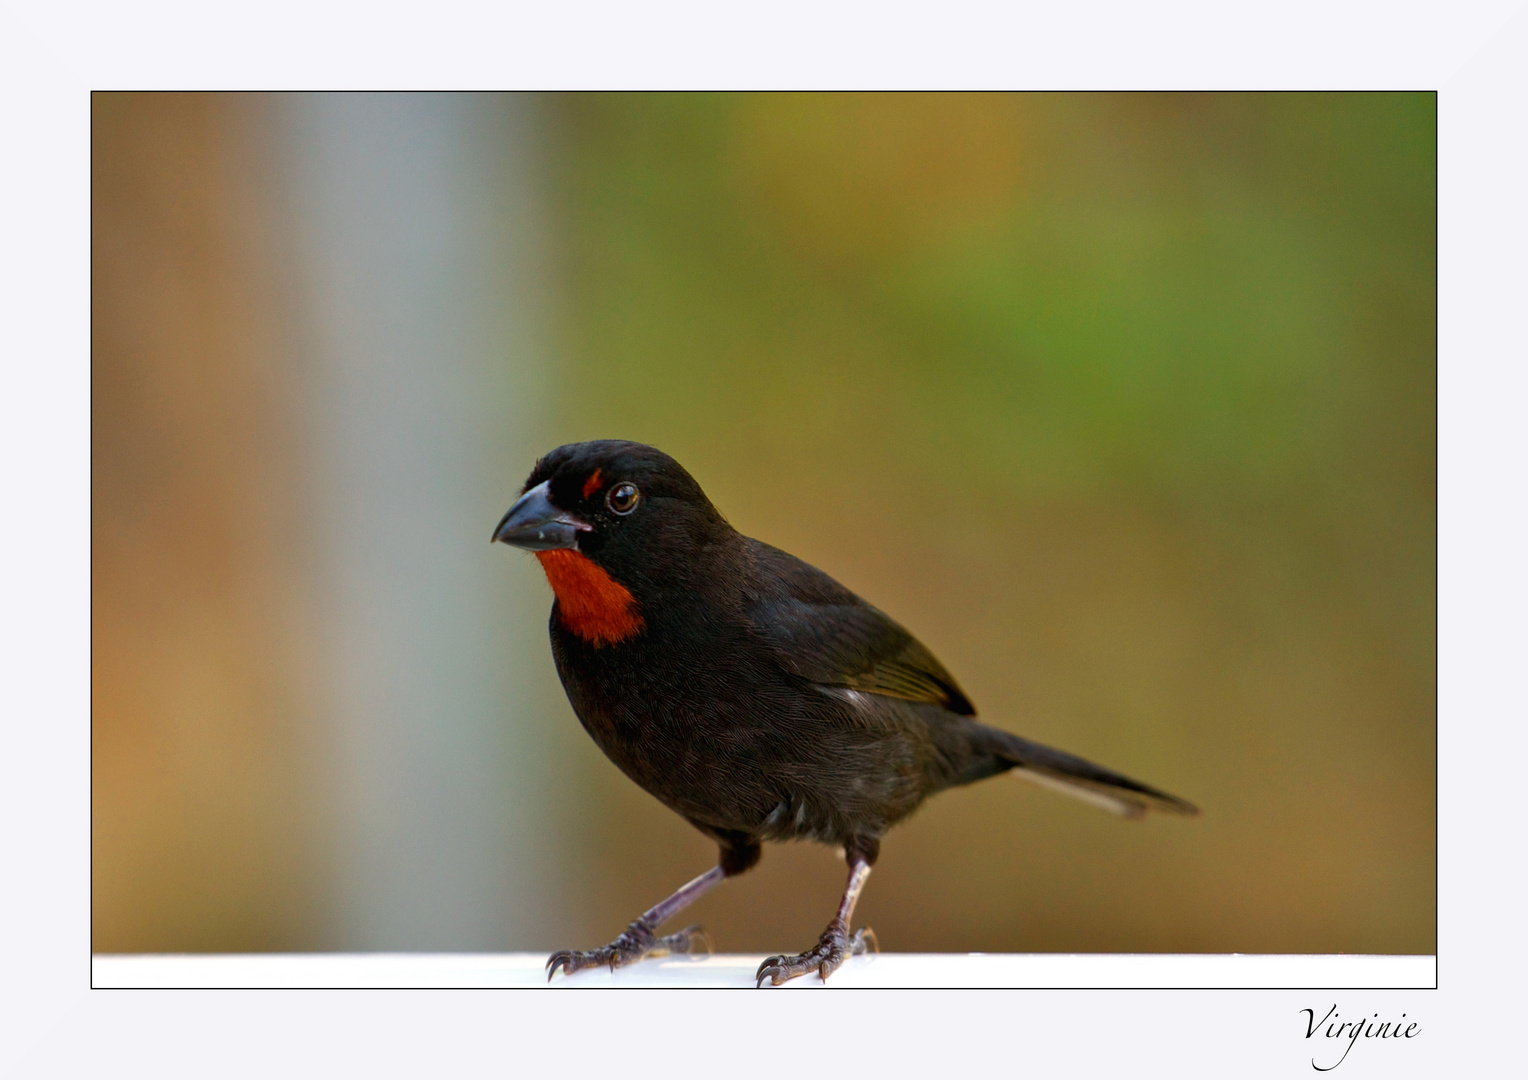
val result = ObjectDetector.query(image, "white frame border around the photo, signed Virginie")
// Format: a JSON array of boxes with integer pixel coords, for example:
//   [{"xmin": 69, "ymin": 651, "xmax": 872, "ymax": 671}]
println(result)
[{"xmin": 0, "ymin": 0, "xmax": 1528, "ymax": 1077}]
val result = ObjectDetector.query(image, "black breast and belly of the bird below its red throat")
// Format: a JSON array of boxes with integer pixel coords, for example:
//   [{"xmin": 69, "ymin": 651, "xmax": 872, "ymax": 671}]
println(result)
[{"xmin": 552, "ymin": 562, "xmax": 970, "ymax": 843}]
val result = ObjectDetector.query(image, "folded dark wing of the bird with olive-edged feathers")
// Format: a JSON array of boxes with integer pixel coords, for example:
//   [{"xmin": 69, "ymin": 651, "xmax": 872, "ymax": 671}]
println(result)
[{"xmin": 749, "ymin": 541, "xmax": 976, "ymax": 716}]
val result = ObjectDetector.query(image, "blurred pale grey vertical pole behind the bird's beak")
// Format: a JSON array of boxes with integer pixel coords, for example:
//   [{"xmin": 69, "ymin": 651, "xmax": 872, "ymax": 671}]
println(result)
[{"xmin": 278, "ymin": 95, "xmax": 556, "ymax": 950}]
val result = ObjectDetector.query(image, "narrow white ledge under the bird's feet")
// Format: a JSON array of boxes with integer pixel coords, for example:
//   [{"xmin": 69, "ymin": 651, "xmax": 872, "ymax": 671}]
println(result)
[{"xmin": 90, "ymin": 953, "xmax": 1438, "ymax": 990}]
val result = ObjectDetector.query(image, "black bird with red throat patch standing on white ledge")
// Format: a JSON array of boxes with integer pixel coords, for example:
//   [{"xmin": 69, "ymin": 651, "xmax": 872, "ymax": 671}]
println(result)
[{"xmin": 494, "ymin": 440, "xmax": 1198, "ymax": 985}]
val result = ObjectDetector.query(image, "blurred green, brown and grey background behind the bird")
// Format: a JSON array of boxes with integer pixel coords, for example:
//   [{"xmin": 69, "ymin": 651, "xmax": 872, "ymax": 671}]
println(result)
[{"xmin": 92, "ymin": 93, "xmax": 1436, "ymax": 953}]
